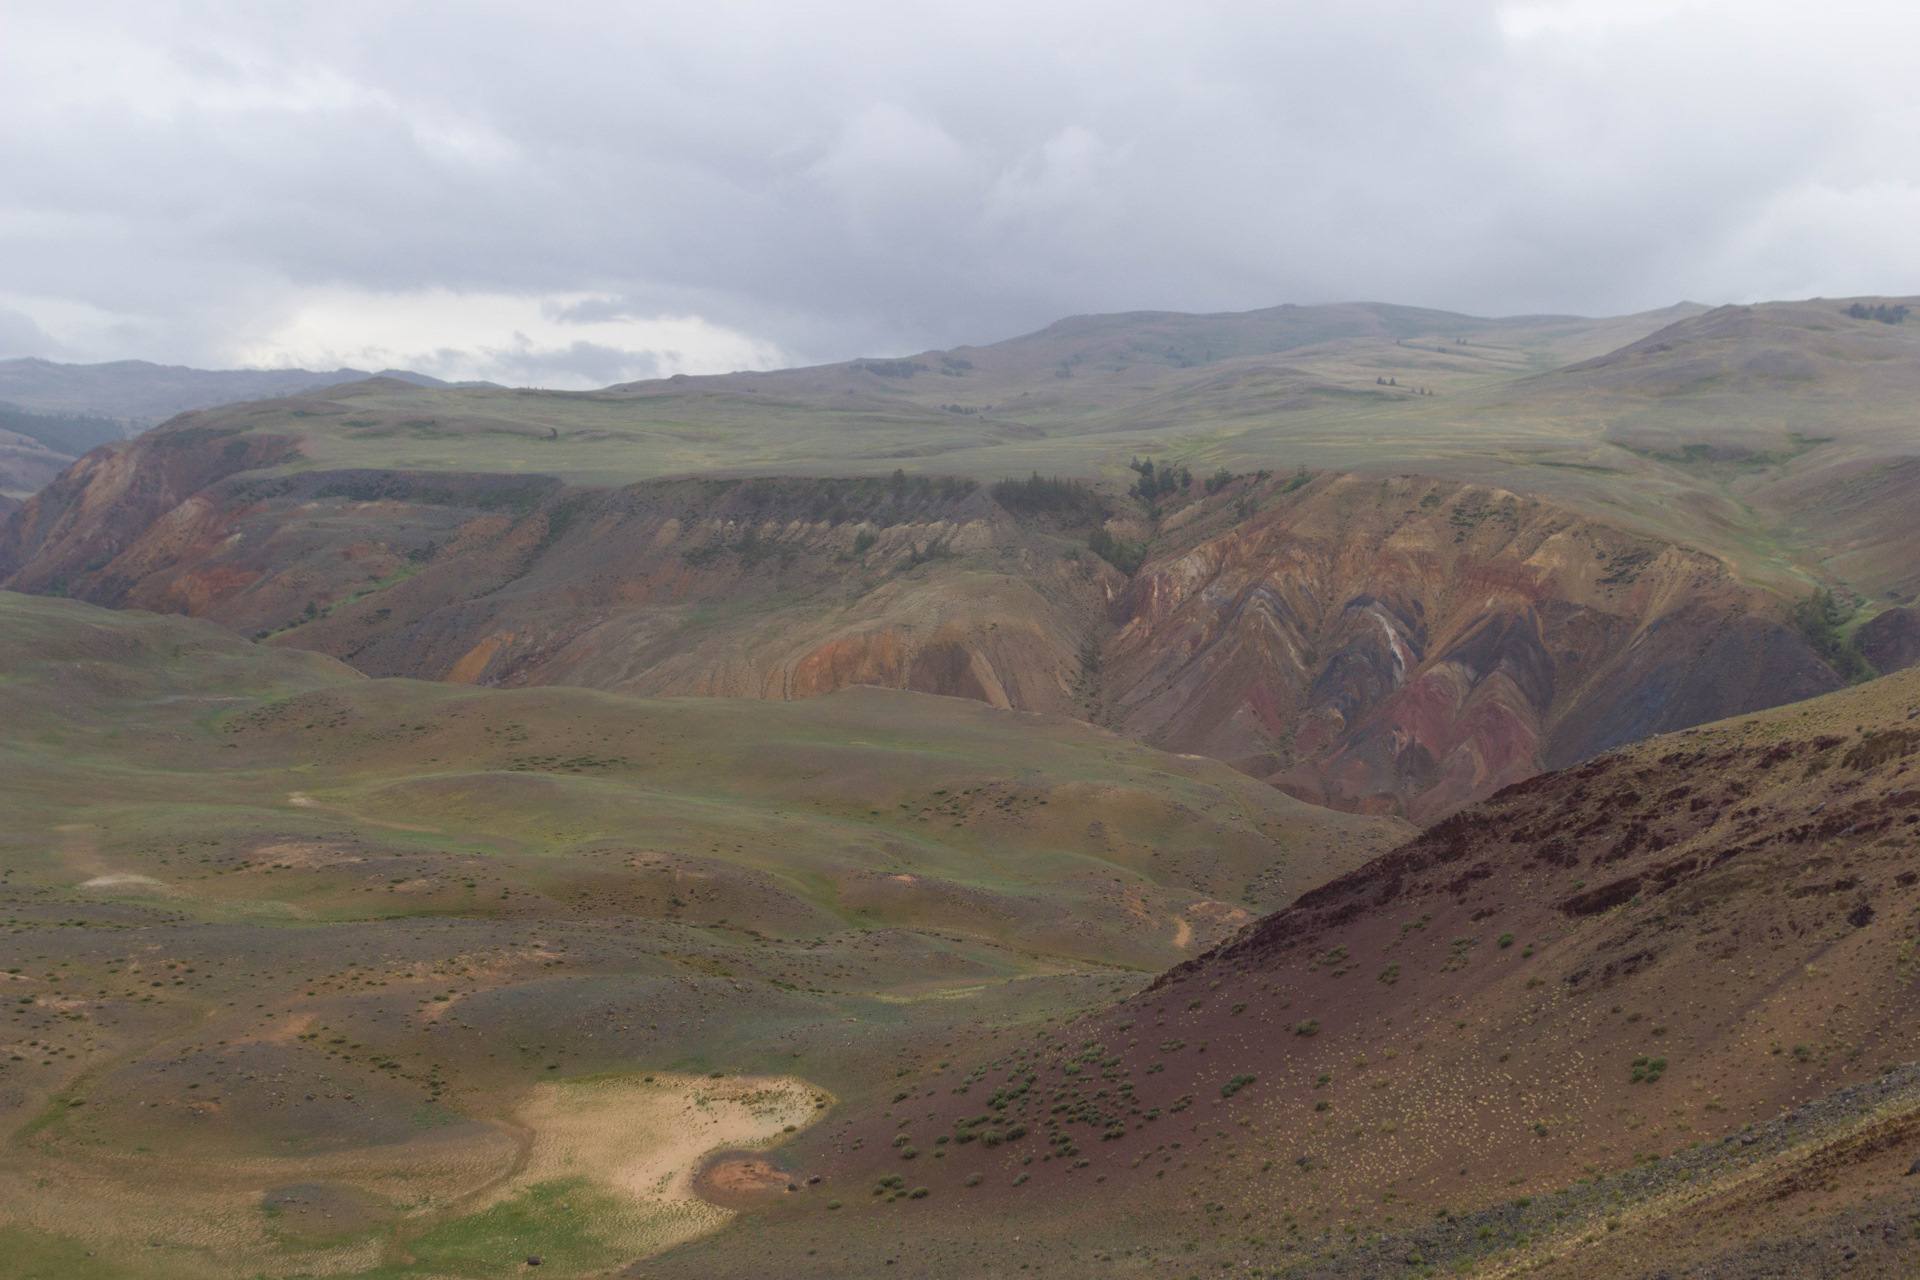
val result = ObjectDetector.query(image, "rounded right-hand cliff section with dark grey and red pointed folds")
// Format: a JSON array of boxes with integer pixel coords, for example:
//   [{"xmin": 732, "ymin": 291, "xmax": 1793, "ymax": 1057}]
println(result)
[{"xmin": 1108, "ymin": 476, "xmax": 1837, "ymax": 821}]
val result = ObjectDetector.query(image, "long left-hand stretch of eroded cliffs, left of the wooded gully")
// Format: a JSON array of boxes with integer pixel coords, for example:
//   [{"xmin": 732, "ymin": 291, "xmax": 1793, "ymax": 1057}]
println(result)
[{"xmin": 4, "ymin": 454, "xmax": 1125, "ymax": 714}]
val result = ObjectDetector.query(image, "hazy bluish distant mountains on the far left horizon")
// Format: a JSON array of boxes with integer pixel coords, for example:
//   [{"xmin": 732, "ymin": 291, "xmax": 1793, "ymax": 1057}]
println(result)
[{"xmin": 0, "ymin": 357, "xmax": 493, "ymax": 455}]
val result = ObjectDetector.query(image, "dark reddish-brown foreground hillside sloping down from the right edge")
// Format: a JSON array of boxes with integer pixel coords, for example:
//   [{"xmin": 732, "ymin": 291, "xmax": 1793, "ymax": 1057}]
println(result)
[{"xmin": 689, "ymin": 672, "xmax": 1920, "ymax": 1274}]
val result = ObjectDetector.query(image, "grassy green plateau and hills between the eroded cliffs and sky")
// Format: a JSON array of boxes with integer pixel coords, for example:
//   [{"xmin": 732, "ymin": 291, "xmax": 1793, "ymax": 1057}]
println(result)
[{"xmin": 145, "ymin": 301, "xmax": 1920, "ymax": 591}]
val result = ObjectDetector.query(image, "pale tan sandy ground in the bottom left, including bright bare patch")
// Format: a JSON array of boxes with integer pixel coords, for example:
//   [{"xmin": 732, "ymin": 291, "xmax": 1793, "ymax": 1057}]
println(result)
[{"xmin": 0, "ymin": 1073, "xmax": 833, "ymax": 1280}]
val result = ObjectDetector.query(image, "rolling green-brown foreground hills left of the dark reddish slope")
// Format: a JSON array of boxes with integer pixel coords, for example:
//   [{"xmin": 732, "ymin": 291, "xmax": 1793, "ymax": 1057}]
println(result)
[{"xmin": 0, "ymin": 595, "xmax": 1405, "ymax": 1276}]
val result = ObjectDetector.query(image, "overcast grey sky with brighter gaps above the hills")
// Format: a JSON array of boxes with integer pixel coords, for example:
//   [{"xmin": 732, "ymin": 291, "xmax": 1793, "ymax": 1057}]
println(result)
[{"xmin": 0, "ymin": 0, "xmax": 1920, "ymax": 388}]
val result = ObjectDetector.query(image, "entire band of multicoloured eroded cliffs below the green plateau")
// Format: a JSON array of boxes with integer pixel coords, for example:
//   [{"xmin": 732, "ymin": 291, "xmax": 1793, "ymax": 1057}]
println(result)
[{"xmin": 0, "ymin": 426, "xmax": 1837, "ymax": 821}]
